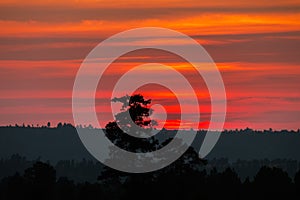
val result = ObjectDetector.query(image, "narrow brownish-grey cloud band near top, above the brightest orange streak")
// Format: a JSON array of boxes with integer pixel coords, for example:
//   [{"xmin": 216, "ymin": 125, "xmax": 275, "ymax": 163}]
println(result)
[{"xmin": 0, "ymin": 5, "xmax": 300, "ymax": 22}]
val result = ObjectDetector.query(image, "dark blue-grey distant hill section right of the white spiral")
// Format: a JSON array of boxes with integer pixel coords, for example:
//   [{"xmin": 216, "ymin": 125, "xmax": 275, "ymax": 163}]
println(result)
[{"xmin": 200, "ymin": 129, "xmax": 300, "ymax": 161}]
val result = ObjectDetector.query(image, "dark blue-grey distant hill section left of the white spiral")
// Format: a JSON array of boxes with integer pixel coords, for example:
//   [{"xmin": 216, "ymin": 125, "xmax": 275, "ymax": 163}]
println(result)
[{"xmin": 0, "ymin": 127, "xmax": 93, "ymax": 163}]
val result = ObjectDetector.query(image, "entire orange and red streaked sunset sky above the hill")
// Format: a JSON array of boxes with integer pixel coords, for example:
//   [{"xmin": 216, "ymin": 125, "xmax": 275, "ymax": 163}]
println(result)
[{"xmin": 0, "ymin": 0, "xmax": 300, "ymax": 130}]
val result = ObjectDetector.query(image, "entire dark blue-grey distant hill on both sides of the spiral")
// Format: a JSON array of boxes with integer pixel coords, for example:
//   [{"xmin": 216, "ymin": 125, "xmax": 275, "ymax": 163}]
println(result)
[{"xmin": 0, "ymin": 126, "xmax": 300, "ymax": 163}]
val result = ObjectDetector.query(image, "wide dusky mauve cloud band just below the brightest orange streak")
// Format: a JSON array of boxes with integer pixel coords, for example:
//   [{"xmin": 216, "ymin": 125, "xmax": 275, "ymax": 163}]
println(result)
[{"xmin": 0, "ymin": 31, "xmax": 300, "ymax": 64}]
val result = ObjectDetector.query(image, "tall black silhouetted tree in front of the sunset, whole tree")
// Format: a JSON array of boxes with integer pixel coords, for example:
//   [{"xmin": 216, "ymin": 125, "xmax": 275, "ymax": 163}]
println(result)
[{"xmin": 98, "ymin": 94, "xmax": 205, "ymax": 189}]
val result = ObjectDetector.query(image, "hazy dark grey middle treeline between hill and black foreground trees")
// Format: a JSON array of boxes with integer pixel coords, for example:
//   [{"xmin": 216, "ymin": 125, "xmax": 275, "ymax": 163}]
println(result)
[{"xmin": 0, "ymin": 154, "xmax": 300, "ymax": 183}]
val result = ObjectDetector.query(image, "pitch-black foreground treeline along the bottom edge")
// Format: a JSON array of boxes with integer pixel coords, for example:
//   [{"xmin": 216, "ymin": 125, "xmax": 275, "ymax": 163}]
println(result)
[{"xmin": 0, "ymin": 161, "xmax": 300, "ymax": 200}]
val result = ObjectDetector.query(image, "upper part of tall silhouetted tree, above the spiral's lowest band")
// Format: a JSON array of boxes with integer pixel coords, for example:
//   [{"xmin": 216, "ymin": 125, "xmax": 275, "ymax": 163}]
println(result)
[{"xmin": 105, "ymin": 94, "xmax": 158, "ymax": 152}]
